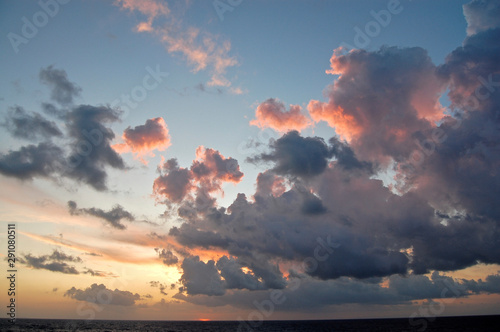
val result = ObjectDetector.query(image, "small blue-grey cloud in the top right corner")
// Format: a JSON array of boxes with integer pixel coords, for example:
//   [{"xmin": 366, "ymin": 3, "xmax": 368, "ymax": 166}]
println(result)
[{"xmin": 463, "ymin": 0, "xmax": 500, "ymax": 36}]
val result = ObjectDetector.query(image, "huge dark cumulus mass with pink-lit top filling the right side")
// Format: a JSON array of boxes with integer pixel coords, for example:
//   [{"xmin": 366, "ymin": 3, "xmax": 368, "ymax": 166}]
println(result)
[{"xmin": 165, "ymin": 1, "xmax": 500, "ymax": 304}]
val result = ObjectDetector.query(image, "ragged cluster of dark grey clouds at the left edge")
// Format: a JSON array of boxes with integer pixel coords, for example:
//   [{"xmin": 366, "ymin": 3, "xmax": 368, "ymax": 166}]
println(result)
[{"xmin": 0, "ymin": 67, "xmax": 125, "ymax": 191}]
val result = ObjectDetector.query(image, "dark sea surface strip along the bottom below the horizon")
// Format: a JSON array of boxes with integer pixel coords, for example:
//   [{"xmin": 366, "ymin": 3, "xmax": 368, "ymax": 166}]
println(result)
[{"xmin": 0, "ymin": 316, "xmax": 500, "ymax": 332}]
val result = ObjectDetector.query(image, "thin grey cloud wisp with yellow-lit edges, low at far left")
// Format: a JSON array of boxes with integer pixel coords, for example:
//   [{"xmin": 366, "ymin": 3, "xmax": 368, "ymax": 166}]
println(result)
[{"xmin": 20, "ymin": 250, "xmax": 83, "ymax": 274}]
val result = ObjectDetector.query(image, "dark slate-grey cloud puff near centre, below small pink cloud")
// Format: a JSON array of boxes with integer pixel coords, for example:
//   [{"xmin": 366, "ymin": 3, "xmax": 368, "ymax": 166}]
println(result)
[{"xmin": 247, "ymin": 131, "xmax": 332, "ymax": 177}]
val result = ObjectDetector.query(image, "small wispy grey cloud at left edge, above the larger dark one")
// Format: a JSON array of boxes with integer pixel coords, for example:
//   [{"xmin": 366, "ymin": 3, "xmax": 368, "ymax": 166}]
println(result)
[{"xmin": 1, "ymin": 106, "xmax": 62, "ymax": 141}]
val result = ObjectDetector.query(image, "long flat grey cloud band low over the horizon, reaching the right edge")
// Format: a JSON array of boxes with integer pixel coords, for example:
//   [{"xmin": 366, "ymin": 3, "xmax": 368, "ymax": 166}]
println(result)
[{"xmin": 174, "ymin": 273, "xmax": 499, "ymax": 314}]
